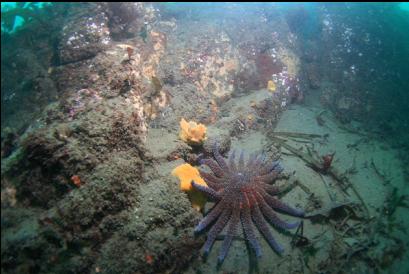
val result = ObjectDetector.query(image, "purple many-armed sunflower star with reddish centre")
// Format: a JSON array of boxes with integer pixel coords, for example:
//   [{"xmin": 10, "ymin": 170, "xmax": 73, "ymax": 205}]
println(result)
[{"xmin": 191, "ymin": 144, "xmax": 304, "ymax": 263}]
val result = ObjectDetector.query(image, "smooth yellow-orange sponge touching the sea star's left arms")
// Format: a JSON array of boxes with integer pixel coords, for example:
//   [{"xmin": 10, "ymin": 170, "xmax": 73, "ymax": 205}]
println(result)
[{"xmin": 172, "ymin": 164, "xmax": 207, "ymax": 211}]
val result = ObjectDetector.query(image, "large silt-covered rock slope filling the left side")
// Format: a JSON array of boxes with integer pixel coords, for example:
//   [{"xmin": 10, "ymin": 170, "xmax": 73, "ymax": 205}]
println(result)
[{"xmin": 1, "ymin": 3, "xmax": 203, "ymax": 273}]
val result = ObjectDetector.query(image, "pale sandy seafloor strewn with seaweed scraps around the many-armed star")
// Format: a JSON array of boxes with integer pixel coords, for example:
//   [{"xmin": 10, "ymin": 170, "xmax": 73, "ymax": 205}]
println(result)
[{"xmin": 148, "ymin": 90, "xmax": 409, "ymax": 273}]
